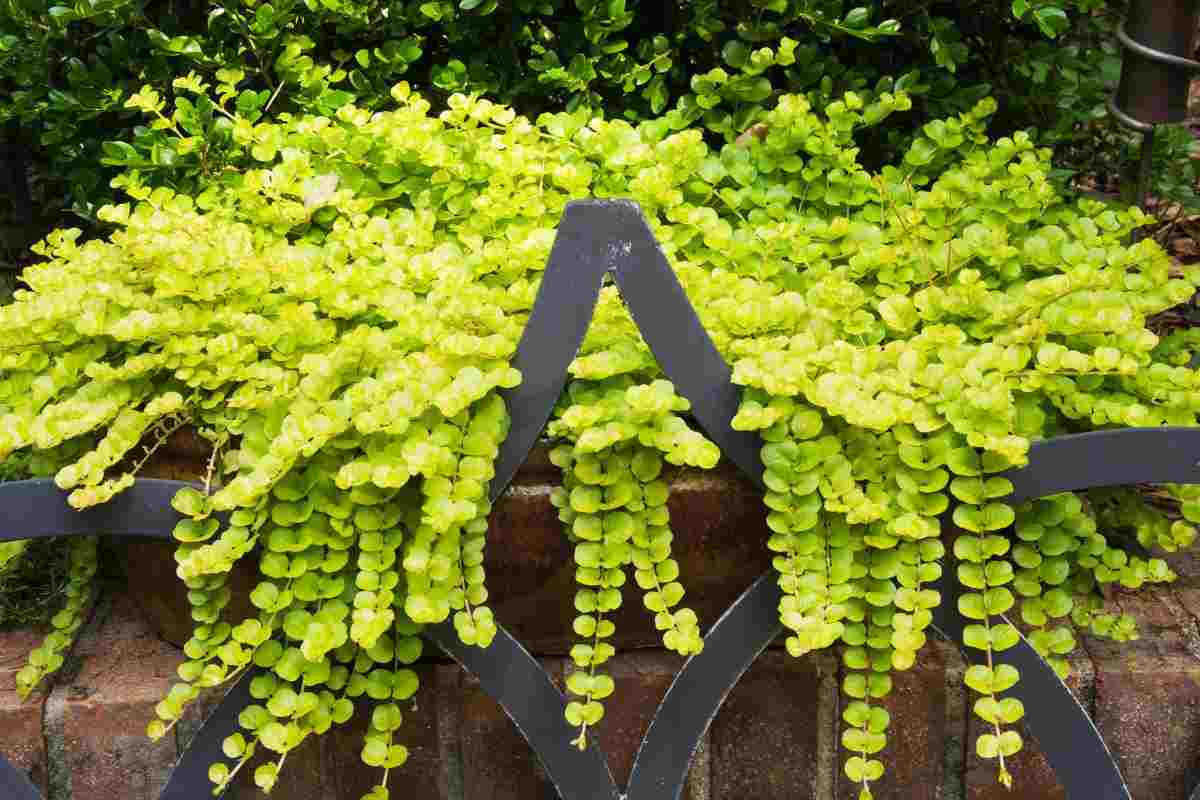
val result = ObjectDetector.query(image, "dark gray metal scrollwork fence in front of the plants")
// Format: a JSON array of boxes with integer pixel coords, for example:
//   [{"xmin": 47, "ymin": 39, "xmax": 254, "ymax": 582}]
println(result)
[{"xmin": 0, "ymin": 195, "xmax": 1200, "ymax": 800}]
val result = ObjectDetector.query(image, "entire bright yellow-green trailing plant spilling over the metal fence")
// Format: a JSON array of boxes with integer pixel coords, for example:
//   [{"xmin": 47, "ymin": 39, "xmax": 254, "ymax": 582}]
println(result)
[{"xmin": 0, "ymin": 77, "xmax": 1200, "ymax": 800}]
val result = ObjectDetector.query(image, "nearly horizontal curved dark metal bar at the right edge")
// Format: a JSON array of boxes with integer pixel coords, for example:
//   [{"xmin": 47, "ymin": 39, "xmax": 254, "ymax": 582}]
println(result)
[{"xmin": 1004, "ymin": 427, "xmax": 1200, "ymax": 503}]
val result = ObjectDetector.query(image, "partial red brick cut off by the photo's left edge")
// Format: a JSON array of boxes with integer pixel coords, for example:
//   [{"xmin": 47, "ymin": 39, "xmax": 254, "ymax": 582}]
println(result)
[{"xmin": 0, "ymin": 631, "xmax": 47, "ymax": 794}]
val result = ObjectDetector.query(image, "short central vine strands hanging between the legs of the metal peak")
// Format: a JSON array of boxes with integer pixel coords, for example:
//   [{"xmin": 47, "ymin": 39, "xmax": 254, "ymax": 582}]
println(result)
[{"xmin": 547, "ymin": 377, "xmax": 705, "ymax": 750}]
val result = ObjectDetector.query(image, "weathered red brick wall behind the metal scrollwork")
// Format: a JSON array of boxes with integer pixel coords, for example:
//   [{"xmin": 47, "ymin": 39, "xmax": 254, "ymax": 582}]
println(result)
[{"xmin": 0, "ymin": 441, "xmax": 1200, "ymax": 800}]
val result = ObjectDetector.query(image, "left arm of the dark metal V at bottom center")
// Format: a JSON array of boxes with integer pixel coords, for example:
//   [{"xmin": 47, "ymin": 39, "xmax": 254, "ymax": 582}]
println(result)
[{"xmin": 425, "ymin": 622, "xmax": 620, "ymax": 800}]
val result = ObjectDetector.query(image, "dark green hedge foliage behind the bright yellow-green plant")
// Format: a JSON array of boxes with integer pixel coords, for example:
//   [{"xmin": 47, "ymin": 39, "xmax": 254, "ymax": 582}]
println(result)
[{"xmin": 0, "ymin": 0, "xmax": 1176, "ymax": 272}]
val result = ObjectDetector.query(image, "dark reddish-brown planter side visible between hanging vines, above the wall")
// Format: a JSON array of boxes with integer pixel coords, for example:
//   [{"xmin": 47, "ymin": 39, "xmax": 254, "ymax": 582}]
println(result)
[{"xmin": 120, "ymin": 462, "xmax": 770, "ymax": 654}]
